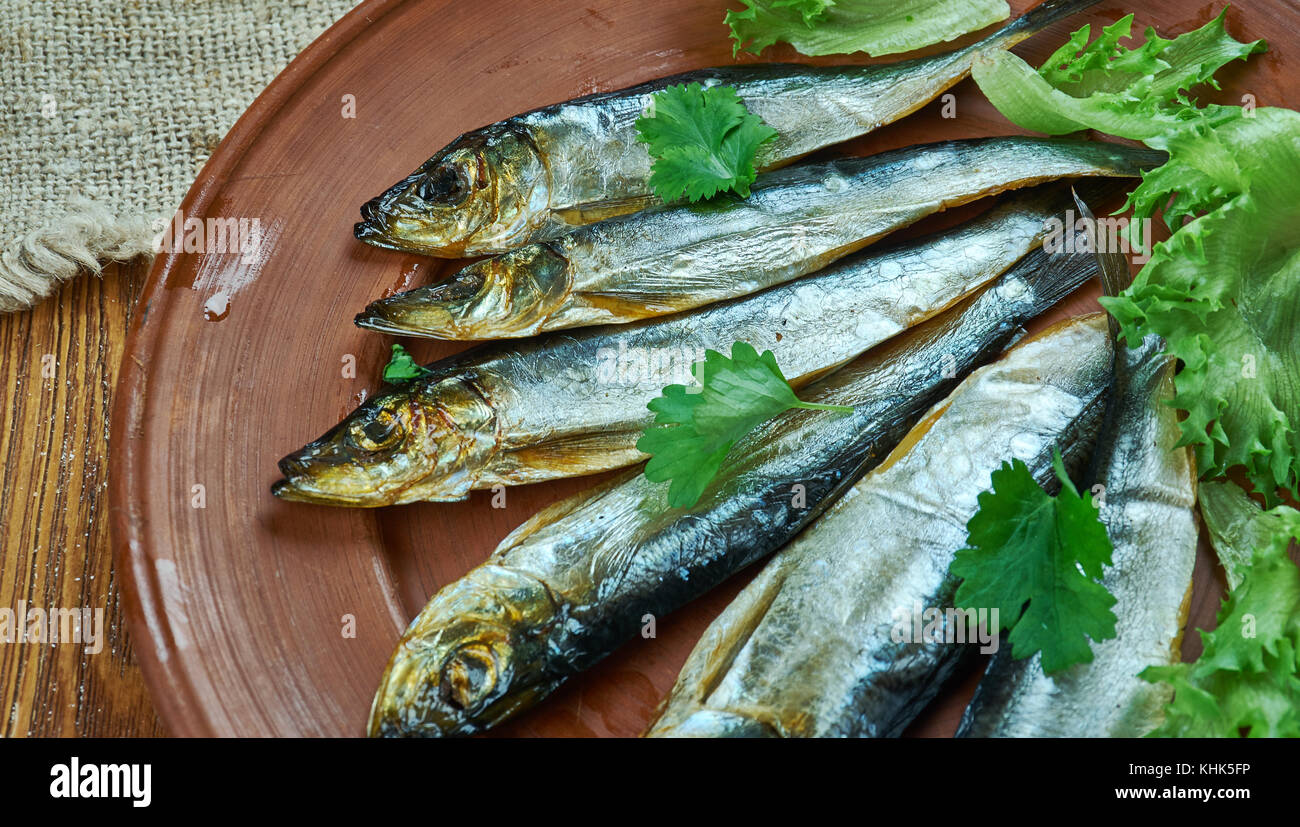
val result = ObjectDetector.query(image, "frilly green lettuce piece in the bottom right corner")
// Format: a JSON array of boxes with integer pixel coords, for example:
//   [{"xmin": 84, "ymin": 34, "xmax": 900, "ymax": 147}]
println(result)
[{"xmin": 1141, "ymin": 514, "xmax": 1300, "ymax": 737}]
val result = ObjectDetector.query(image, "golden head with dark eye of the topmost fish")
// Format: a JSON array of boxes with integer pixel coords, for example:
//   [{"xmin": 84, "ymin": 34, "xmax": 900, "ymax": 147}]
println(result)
[{"xmin": 354, "ymin": 126, "xmax": 550, "ymax": 259}]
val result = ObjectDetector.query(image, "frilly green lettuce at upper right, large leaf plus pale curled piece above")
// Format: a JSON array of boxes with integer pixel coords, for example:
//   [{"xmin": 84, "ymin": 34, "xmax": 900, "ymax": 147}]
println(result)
[{"xmin": 972, "ymin": 10, "xmax": 1300, "ymax": 503}]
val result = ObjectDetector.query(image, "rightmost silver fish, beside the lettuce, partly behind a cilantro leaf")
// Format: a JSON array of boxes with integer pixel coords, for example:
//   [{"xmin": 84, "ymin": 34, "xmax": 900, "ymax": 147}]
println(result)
[{"xmin": 958, "ymin": 337, "xmax": 1197, "ymax": 737}]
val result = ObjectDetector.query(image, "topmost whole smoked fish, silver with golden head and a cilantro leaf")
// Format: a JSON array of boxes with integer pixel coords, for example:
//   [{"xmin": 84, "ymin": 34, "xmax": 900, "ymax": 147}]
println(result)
[{"xmin": 355, "ymin": 0, "xmax": 1097, "ymax": 258}]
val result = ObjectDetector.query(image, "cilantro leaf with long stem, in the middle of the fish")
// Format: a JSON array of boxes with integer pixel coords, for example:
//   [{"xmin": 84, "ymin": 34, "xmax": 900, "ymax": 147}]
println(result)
[{"xmin": 637, "ymin": 342, "xmax": 853, "ymax": 508}]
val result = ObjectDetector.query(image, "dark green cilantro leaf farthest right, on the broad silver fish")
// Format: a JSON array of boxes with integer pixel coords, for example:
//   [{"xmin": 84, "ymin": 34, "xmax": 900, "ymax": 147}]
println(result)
[{"xmin": 950, "ymin": 451, "xmax": 1115, "ymax": 675}]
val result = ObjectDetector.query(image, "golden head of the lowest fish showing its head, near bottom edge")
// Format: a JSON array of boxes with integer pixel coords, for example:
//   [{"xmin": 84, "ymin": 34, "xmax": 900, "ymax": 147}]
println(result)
[{"xmin": 369, "ymin": 563, "xmax": 559, "ymax": 737}]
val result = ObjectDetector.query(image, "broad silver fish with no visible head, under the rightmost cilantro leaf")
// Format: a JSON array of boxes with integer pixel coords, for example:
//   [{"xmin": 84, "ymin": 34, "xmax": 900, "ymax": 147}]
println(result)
[{"xmin": 650, "ymin": 316, "xmax": 1112, "ymax": 736}]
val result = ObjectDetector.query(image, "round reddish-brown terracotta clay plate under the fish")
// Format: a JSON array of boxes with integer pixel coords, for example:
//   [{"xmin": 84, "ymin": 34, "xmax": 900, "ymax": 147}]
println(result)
[{"xmin": 112, "ymin": 0, "xmax": 1300, "ymax": 736}]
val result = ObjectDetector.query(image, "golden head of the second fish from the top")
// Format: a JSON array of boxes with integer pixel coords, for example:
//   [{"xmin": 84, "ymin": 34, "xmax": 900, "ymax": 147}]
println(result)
[{"xmin": 356, "ymin": 243, "xmax": 573, "ymax": 339}]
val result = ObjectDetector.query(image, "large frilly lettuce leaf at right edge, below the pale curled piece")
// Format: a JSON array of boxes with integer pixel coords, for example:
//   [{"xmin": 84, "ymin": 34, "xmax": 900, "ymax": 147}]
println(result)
[{"xmin": 1101, "ymin": 109, "xmax": 1300, "ymax": 496}]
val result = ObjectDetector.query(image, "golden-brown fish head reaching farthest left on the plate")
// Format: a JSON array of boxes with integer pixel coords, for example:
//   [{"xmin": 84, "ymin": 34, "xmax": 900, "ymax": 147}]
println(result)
[{"xmin": 270, "ymin": 376, "xmax": 495, "ymax": 507}]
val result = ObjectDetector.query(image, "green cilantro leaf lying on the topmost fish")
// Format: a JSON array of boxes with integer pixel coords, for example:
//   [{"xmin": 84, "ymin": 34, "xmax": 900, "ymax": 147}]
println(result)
[{"xmin": 637, "ymin": 82, "xmax": 776, "ymax": 202}]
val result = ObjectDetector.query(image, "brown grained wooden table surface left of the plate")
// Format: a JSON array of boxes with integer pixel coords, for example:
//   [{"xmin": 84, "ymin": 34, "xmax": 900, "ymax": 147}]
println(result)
[{"xmin": 0, "ymin": 260, "xmax": 166, "ymax": 737}]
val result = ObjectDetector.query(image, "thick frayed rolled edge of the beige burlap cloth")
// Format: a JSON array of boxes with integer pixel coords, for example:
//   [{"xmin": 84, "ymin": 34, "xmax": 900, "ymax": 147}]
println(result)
[{"xmin": 0, "ymin": 199, "xmax": 155, "ymax": 312}]
